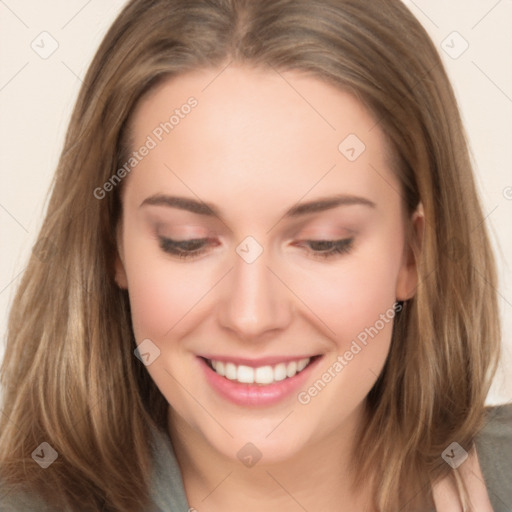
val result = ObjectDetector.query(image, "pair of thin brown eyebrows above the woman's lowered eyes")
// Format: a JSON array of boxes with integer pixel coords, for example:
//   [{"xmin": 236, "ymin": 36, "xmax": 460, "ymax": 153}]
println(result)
[{"xmin": 140, "ymin": 194, "xmax": 376, "ymax": 219}]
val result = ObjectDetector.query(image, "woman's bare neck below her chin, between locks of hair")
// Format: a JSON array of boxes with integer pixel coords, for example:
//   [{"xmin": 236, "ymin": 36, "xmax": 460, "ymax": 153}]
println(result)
[{"xmin": 169, "ymin": 406, "xmax": 370, "ymax": 512}]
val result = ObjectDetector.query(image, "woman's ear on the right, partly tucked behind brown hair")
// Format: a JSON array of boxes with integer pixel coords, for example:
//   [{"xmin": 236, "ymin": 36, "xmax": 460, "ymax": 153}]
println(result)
[{"xmin": 396, "ymin": 203, "xmax": 425, "ymax": 301}]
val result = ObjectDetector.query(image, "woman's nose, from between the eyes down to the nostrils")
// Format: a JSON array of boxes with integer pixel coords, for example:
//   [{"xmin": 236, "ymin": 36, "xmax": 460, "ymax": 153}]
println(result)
[{"xmin": 218, "ymin": 244, "xmax": 293, "ymax": 340}]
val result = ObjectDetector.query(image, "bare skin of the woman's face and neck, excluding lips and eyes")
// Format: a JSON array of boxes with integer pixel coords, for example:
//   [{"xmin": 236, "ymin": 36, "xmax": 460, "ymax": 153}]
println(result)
[{"xmin": 116, "ymin": 66, "xmax": 492, "ymax": 512}]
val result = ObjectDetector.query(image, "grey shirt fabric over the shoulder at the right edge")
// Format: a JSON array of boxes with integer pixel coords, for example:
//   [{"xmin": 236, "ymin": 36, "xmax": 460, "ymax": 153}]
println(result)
[{"xmin": 475, "ymin": 403, "xmax": 512, "ymax": 512}]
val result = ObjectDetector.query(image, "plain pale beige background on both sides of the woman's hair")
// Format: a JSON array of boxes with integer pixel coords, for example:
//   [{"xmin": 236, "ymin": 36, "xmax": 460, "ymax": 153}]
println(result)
[{"xmin": 0, "ymin": 0, "xmax": 512, "ymax": 403}]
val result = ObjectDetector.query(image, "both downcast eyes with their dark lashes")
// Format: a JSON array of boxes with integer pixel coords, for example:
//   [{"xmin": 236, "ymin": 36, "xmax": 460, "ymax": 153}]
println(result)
[{"xmin": 159, "ymin": 237, "xmax": 354, "ymax": 259}]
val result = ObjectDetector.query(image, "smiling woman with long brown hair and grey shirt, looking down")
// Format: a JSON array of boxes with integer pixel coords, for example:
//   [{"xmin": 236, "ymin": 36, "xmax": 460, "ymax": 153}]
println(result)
[{"xmin": 0, "ymin": 0, "xmax": 511, "ymax": 511}]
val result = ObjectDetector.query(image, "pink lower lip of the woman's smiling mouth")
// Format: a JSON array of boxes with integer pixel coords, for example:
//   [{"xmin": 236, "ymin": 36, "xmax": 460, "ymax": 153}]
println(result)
[{"xmin": 198, "ymin": 357, "xmax": 321, "ymax": 406}]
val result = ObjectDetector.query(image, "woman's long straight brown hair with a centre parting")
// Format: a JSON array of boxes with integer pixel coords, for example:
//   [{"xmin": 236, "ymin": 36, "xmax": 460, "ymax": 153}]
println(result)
[{"xmin": 0, "ymin": 0, "xmax": 500, "ymax": 512}]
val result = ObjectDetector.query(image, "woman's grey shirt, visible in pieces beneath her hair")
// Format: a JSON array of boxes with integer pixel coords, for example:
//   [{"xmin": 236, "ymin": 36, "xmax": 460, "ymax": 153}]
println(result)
[{"xmin": 0, "ymin": 403, "xmax": 512, "ymax": 512}]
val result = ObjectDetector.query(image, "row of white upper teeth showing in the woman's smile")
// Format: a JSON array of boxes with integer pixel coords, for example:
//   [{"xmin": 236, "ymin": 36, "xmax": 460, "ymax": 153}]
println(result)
[{"xmin": 210, "ymin": 357, "xmax": 311, "ymax": 385}]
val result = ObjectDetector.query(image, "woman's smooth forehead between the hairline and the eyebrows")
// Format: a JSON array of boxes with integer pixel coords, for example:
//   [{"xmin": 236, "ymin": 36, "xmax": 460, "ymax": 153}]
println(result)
[{"xmin": 123, "ymin": 65, "xmax": 396, "ymax": 216}]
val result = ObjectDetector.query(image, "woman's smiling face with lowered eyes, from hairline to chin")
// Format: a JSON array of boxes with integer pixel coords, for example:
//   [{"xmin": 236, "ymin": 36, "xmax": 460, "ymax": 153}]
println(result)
[{"xmin": 116, "ymin": 66, "xmax": 416, "ymax": 461}]
